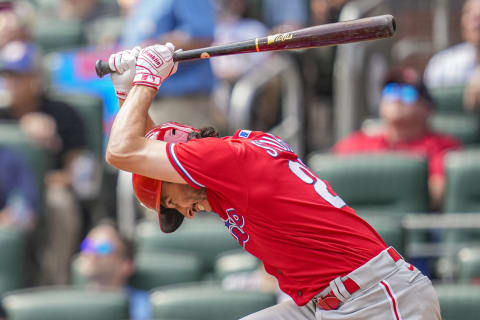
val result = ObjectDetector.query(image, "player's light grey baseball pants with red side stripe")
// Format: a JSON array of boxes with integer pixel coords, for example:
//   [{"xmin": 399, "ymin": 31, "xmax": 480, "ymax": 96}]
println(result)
[{"xmin": 242, "ymin": 250, "xmax": 441, "ymax": 320}]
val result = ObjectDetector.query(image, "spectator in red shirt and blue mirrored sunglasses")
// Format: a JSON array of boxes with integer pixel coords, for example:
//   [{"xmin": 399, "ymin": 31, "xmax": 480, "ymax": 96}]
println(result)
[{"xmin": 333, "ymin": 68, "xmax": 460, "ymax": 209}]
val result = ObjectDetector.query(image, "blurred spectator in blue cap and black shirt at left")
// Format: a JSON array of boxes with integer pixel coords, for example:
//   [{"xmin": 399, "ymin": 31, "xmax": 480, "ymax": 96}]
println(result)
[{"xmin": 0, "ymin": 41, "xmax": 95, "ymax": 284}]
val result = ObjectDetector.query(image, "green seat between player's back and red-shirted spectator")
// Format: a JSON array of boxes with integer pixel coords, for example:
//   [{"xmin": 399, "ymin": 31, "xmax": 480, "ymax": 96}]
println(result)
[{"xmin": 308, "ymin": 153, "xmax": 429, "ymax": 216}]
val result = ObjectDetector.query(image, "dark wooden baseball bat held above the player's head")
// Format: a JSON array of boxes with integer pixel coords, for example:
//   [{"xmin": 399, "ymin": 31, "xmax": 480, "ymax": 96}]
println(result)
[{"xmin": 95, "ymin": 15, "xmax": 397, "ymax": 78}]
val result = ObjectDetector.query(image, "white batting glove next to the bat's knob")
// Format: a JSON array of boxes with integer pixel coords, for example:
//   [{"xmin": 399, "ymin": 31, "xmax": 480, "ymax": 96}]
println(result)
[{"xmin": 108, "ymin": 47, "xmax": 142, "ymax": 100}]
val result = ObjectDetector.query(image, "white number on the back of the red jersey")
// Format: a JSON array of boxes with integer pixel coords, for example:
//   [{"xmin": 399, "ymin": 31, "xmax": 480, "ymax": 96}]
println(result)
[{"xmin": 288, "ymin": 160, "xmax": 346, "ymax": 208}]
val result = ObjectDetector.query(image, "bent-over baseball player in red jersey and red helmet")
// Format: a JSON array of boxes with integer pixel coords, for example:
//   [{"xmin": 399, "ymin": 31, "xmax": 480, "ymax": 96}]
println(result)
[{"xmin": 106, "ymin": 43, "xmax": 441, "ymax": 320}]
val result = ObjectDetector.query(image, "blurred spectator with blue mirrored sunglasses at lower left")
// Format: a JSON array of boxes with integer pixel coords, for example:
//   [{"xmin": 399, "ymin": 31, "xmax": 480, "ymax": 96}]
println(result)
[{"xmin": 78, "ymin": 222, "xmax": 151, "ymax": 320}]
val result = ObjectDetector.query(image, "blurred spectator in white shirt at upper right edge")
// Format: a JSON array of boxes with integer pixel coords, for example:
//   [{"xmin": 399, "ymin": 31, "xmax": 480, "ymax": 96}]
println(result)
[{"xmin": 425, "ymin": 0, "xmax": 480, "ymax": 110}]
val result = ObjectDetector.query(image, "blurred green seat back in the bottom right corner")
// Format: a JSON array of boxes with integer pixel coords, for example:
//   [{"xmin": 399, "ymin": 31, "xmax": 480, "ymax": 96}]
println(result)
[{"xmin": 435, "ymin": 285, "xmax": 480, "ymax": 320}]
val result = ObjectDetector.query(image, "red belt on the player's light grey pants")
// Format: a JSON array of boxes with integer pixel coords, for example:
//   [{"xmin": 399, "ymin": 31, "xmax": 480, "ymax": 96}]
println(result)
[{"xmin": 313, "ymin": 247, "xmax": 402, "ymax": 310}]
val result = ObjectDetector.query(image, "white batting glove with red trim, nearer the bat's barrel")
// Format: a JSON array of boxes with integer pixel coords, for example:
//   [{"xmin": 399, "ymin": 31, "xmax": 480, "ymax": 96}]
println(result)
[{"xmin": 133, "ymin": 42, "xmax": 178, "ymax": 90}]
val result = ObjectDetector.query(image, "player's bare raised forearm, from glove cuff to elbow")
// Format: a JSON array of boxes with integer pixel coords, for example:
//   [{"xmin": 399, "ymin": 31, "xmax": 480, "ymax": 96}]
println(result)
[{"xmin": 106, "ymin": 86, "xmax": 157, "ymax": 169}]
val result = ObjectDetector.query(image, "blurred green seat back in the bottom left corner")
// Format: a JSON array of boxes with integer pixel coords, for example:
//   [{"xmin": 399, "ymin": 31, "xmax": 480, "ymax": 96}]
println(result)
[{"xmin": 3, "ymin": 287, "xmax": 129, "ymax": 320}]
